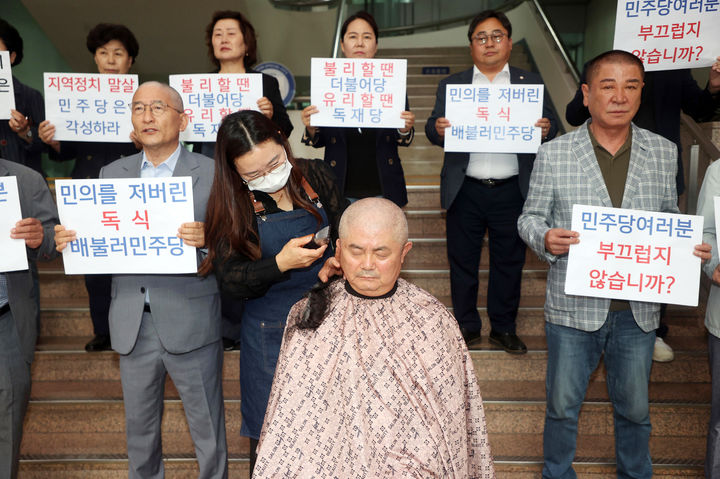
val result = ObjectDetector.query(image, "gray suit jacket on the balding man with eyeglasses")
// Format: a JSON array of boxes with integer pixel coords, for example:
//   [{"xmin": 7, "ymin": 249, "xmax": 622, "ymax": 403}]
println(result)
[{"xmin": 100, "ymin": 148, "xmax": 220, "ymax": 354}]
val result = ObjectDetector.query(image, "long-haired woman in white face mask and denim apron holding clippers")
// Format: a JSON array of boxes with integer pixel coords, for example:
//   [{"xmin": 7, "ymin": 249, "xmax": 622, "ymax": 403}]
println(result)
[{"xmin": 200, "ymin": 110, "xmax": 346, "ymax": 471}]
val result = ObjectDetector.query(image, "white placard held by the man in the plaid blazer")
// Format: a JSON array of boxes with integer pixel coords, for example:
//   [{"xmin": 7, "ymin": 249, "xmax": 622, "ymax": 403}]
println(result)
[{"xmin": 565, "ymin": 205, "xmax": 703, "ymax": 306}]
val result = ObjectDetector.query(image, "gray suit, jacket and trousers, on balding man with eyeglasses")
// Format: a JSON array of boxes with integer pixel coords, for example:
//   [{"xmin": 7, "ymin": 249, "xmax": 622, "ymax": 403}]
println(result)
[{"xmin": 100, "ymin": 148, "xmax": 227, "ymax": 478}]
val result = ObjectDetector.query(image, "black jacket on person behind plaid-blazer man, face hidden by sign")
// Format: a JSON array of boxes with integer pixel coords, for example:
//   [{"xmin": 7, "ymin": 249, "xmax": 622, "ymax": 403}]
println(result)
[{"xmin": 565, "ymin": 69, "xmax": 720, "ymax": 196}]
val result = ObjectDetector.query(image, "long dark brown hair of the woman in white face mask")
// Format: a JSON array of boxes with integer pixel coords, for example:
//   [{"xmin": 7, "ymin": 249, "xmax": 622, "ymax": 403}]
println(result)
[{"xmin": 198, "ymin": 110, "xmax": 322, "ymax": 275}]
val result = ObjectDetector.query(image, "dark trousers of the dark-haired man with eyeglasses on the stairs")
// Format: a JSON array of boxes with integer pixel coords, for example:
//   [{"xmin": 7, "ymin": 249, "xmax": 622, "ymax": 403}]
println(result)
[{"xmin": 446, "ymin": 177, "xmax": 526, "ymax": 333}]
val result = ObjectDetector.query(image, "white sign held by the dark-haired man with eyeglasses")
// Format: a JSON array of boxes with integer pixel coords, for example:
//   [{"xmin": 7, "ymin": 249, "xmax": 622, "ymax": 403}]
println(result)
[{"xmin": 445, "ymin": 85, "xmax": 544, "ymax": 153}]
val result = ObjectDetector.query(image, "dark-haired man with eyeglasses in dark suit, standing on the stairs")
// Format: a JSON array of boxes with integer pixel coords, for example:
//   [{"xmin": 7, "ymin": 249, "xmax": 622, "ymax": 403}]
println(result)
[{"xmin": 425, "ymin": 10, "xmax": 557, "ymax": 354}]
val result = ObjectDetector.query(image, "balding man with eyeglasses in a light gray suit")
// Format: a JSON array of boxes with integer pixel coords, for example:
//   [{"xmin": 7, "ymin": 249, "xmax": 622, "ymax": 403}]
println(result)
[{"xmin": 55, "ymin": 82, "xmax": 227, "ymax": 479}]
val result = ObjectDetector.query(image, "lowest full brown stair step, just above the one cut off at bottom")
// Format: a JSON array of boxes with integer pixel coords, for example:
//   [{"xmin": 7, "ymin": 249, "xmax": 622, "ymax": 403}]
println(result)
[{"xmin": 21, "ymin": 400, "xmax": 710, "ymax": 464}]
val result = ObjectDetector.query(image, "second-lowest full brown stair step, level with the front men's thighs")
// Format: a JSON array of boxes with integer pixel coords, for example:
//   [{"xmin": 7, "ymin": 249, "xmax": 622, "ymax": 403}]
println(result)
[{"xmin": 31, "ymin": 344, "xmax": 710, "ymax": 403}]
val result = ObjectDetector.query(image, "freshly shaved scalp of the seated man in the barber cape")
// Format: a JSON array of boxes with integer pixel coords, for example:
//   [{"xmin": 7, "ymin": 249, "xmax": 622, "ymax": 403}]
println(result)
[{"xmin": 338, "ymin": 198, "xmax": 408, "ymax": 244}]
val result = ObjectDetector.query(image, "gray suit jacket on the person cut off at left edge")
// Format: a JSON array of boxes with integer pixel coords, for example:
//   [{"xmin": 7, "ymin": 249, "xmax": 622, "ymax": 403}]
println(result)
[{"xmin": 0, "ymin": 159, "xmax": 59, "ymax": 363}]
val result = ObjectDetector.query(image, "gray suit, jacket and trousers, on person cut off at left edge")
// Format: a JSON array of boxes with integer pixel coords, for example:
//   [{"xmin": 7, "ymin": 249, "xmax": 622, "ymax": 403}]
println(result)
[{"xmin": 0, "ymin": 159, "xmax": 58, "ymax": 478}]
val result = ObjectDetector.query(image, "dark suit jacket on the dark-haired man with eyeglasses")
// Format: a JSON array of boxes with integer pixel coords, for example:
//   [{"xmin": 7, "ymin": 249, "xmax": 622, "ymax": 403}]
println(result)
[{"xmin": 425, "ymin": 67, "xmax": 558, "ymax": 209}]
